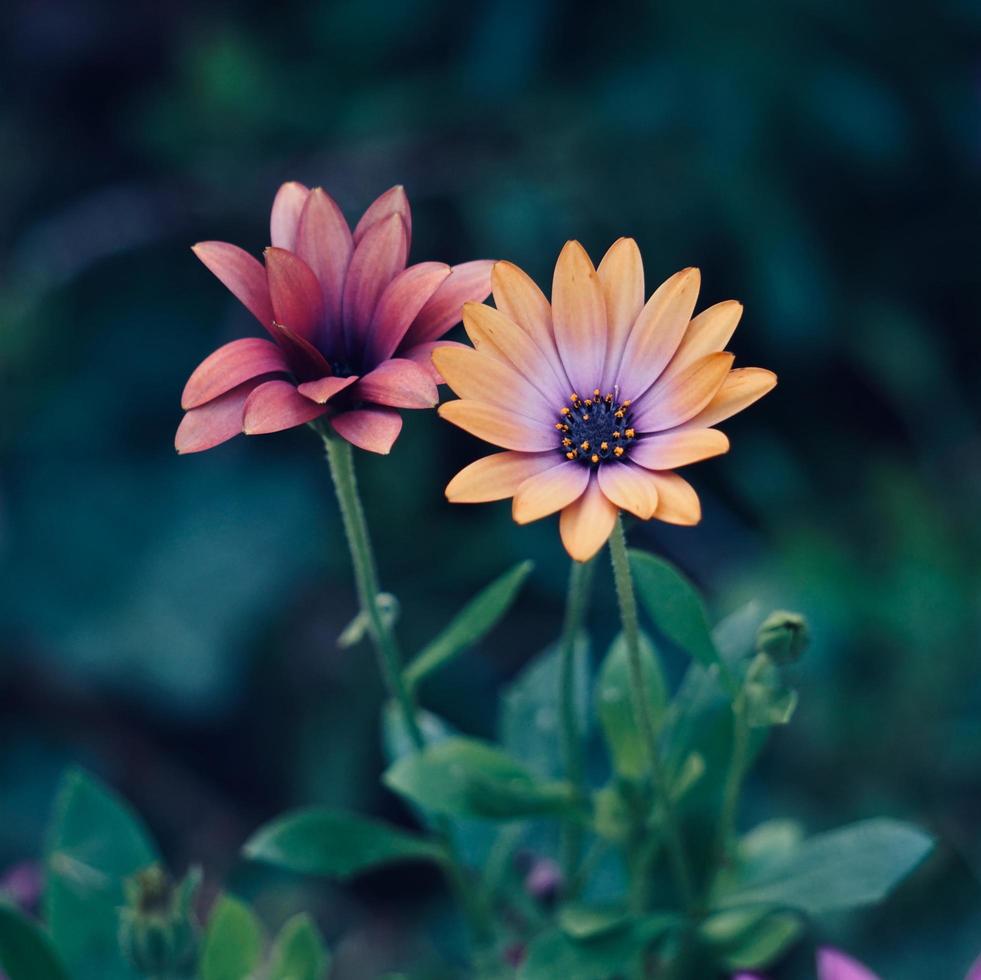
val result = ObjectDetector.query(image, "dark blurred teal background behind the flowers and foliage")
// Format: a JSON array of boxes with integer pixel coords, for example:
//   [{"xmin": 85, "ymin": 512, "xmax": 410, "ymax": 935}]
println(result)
[{"xmin": 0, "ymin": 0, "xmax": 981, "ymax": 980}]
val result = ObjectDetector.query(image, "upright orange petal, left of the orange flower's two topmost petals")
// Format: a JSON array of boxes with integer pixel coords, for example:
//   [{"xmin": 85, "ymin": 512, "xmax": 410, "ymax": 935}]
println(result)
[{"xmin": 552, "ymin": 241, "xmax": 607, "ymax": 393}]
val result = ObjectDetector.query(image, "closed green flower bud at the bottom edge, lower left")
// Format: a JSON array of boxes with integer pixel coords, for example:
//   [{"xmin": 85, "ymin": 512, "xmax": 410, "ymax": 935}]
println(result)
[{"xmin": 119, "ymin": 864, "xmax": 201, "ymax": 978}]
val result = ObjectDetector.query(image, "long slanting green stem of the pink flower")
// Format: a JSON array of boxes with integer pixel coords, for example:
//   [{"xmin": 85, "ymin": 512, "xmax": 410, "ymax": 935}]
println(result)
[{"xmin": 315, "ymin": 426, "xmax": 492, "ymax": 956}]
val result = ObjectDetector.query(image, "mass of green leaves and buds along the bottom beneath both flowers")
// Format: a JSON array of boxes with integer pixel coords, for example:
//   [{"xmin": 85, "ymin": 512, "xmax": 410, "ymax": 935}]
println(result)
[{"xmin": 0, "ymin": 552, "xmax": 932, "ymax": 980}]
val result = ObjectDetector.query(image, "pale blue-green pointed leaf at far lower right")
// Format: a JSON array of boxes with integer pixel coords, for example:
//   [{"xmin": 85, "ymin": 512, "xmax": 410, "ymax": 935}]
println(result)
[{"xmin": 715, "ymin": 818, "xmax": 933, "ymax": 915}]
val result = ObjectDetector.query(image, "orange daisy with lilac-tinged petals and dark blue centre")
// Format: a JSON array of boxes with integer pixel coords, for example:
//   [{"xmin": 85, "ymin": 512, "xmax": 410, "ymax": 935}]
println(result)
[{"xmin": 433, "ymin": 238, "xmax": 777, "ymax": 561}]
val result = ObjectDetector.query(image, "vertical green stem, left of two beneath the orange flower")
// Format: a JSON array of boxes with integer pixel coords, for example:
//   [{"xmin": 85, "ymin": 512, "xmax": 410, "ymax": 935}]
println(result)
[{"xmin": 559, "ymin": 561, "xmax": 593, "ymax": 894}]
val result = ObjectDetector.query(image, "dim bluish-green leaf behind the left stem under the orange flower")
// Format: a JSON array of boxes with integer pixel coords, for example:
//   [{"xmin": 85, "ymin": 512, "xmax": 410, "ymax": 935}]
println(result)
[{"xmin": 499, "ymin": 633, "xmax": 590, "ymax": 779}]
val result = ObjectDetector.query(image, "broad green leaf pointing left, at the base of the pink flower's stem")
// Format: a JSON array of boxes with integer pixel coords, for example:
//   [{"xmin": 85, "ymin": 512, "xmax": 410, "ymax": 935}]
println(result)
[{"xmin": 384, "ymin": 736, "xmax": 574, "ymax": 820}]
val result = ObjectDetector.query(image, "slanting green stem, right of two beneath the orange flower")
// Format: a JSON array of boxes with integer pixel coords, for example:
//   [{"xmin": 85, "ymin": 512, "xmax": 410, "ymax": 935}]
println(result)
[{"xmin": 610, "ymin": 517, "xmax": 695, "ymax": 911}]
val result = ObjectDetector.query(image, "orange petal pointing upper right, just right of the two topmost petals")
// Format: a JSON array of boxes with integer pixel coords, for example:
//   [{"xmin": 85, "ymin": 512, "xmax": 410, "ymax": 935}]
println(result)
[{"xmin": 617, "ymin": 269, "xmax": 701, "ymax": 400}]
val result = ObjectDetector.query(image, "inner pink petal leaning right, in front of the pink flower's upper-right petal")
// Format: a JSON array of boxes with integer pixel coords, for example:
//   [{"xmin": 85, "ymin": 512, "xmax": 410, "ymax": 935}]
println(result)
[{"xmin": 343, "ymin": 214, "xmax": 409, "ymax": 352}]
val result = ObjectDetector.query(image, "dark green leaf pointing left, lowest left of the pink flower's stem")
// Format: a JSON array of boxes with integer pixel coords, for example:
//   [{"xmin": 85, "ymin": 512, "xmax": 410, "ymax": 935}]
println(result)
[{"xmin": 244, "ymin": 807, "xmax": 441, "ymax": 879}]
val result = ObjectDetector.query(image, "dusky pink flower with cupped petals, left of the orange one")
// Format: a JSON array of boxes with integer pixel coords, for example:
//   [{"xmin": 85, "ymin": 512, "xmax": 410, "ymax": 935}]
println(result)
[{"xmin": 174, "ymin": 182, "xmax": 492, "ymax": 453}]
